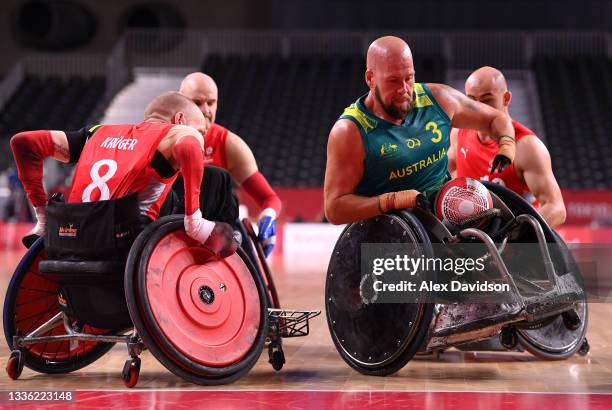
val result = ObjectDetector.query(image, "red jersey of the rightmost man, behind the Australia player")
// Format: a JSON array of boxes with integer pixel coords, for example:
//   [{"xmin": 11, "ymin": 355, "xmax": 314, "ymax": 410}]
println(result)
[{"xmin": 456, "ymin": 120, "xmax": 538, "ymax": 207}]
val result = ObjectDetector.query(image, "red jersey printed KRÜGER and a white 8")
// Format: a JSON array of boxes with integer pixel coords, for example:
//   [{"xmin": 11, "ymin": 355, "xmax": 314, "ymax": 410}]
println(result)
[{"xmin": 68, "ymin": 122, "xmax": 176, "ymax": 220}]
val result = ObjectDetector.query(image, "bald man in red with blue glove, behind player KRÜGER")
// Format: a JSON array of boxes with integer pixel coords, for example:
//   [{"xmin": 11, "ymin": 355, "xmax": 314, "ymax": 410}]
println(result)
[{"xmin": 180, "ymin": 73, "xmax": 282, "ymax": 256}]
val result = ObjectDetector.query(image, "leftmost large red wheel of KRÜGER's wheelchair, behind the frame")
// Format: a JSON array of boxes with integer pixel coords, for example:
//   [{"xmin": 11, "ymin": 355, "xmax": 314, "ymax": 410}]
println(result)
[{"xmin": 3, "ymin": 238, "xmax": 114, "ymax": 373}]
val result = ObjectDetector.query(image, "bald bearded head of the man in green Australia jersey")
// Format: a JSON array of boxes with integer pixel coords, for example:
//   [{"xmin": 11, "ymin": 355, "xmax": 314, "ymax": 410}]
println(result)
[{"xmin": 365, "ymin": 36, "xmax": 414, "ymax": 121}]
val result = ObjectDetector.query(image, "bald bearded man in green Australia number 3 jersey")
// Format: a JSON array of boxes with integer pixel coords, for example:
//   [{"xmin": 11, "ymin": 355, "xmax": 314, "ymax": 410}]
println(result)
[{"xmin": 325, "ymin": 36, "xmax": 515, "ymax": 224}]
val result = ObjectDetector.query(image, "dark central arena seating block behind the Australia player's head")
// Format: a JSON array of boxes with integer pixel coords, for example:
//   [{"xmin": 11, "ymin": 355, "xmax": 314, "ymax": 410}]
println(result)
[{"xmin": 202, "ymin": 55, "xmax": 445, "ymax": 187}]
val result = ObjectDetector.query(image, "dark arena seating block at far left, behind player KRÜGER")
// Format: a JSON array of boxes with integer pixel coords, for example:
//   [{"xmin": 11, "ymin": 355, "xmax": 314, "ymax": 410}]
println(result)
[{"xmin": 0, "ymin": 76, "xmax": 105, "ymax": 169}]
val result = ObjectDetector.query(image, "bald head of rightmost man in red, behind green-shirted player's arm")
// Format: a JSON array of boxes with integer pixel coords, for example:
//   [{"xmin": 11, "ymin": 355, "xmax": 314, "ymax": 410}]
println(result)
[{"xmin": 465, "ymin": 66, "xmax": 512, "ymax": 112}]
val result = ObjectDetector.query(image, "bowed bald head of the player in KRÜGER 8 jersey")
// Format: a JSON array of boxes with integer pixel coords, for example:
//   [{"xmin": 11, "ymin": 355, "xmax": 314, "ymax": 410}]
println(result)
[{"xmin": 144, "ymin": 91, "xmax": 208, "ymax": 134}]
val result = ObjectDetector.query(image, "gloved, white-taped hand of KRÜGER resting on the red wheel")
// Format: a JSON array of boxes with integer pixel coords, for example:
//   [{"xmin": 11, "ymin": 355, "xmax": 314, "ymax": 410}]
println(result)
[{"xmin": 184, "ymin": 209, "xmax": 242, "ymax": 258}]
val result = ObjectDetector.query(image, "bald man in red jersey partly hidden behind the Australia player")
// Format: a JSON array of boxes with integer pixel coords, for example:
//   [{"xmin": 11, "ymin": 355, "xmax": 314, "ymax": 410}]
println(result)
[{"xmin": 448, "ymin": 67, "xmax": 565, "ymax": 228}]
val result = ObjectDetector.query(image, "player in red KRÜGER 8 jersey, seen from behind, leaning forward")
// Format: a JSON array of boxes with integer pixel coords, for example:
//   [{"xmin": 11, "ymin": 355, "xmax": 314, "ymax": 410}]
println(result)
[{"xmin": 11, "ymin": 92, "xmax": 238, "ymax": 256}]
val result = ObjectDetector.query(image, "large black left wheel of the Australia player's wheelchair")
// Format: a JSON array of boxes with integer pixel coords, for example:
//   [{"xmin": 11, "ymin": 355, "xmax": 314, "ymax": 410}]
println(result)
[{"xmin": 325, "ymin": 212, "xmax": 434, "ymax": 376}]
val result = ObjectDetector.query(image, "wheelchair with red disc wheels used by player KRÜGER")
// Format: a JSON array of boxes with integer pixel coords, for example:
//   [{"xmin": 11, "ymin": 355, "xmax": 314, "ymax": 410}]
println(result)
[{"xmin": 3, "ymin": 195, "xmax": 320, "ymax": 387}]
